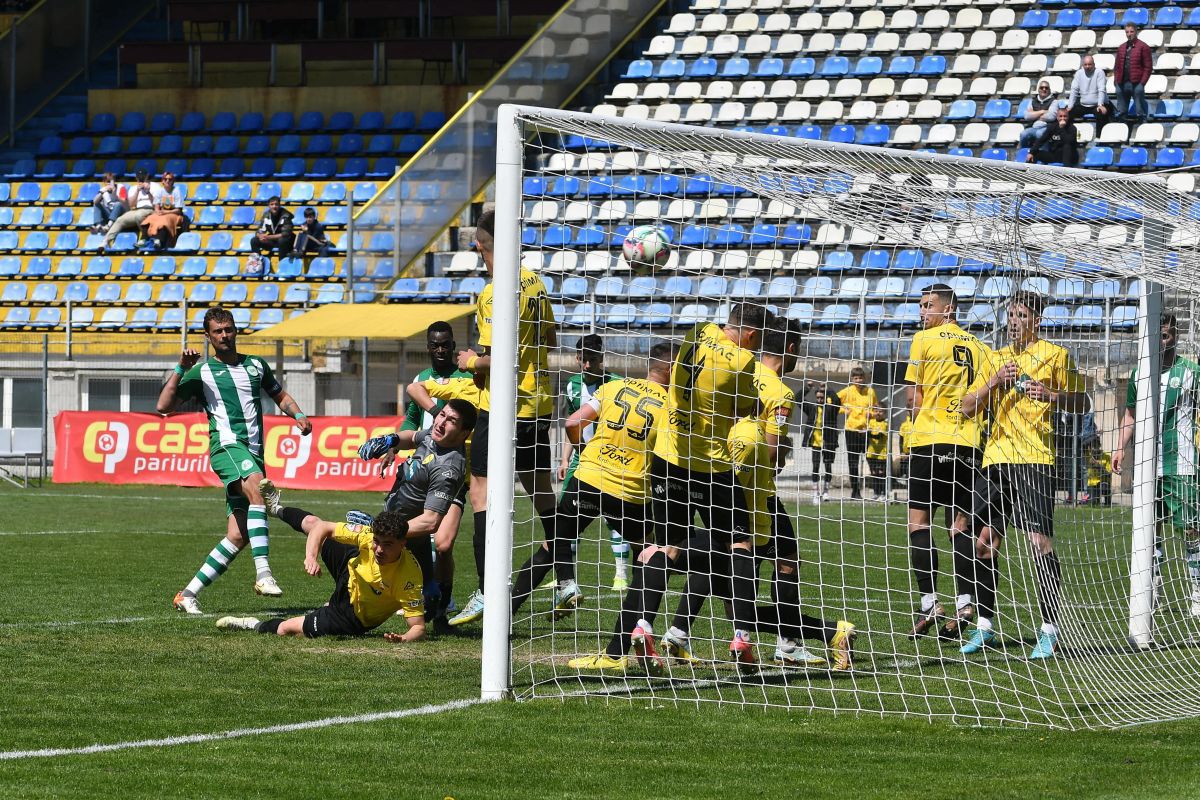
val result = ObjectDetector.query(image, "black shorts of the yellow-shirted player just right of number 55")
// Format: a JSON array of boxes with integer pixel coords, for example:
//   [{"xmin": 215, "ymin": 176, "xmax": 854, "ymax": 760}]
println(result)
[{"xmin": 650, "ymin": 456, "xmax": 754, "ymax": 547}]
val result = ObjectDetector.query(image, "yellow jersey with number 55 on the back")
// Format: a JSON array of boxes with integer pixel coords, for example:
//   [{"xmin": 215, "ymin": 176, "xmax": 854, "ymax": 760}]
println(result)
[{"xmin": 575, "ymin": 378, "xmax": 667, "ymax": 505}]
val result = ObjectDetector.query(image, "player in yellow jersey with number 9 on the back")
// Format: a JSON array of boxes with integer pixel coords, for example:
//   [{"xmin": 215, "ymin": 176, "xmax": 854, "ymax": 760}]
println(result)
[{"xmin": 905, "ymin": 283, "xmax": 991, "ymax": 638}]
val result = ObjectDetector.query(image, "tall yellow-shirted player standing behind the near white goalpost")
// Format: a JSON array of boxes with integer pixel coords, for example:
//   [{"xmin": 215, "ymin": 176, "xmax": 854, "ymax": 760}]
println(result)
[{"xmin": 450, "ymin": 211, "xmax": 558, "ymax": 625}]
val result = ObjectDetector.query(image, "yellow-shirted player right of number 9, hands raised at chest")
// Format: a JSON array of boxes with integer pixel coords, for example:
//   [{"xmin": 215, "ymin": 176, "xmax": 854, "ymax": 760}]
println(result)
[{"xmin": 962, "ymin": 291, "xmax": 1091, "ymax": 660}]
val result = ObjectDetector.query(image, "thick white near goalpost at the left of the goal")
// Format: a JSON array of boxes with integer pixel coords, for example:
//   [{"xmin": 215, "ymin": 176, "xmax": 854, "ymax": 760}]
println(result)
[{"xmin": 480, "ymin": 106, "xmax": 524, "ymax": 700}]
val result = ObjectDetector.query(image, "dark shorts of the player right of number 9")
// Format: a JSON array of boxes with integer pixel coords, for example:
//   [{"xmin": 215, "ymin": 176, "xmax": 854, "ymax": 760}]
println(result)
[{"xmin": 971, "ymin": 464, "xmax": 1054, "ymax": 536}]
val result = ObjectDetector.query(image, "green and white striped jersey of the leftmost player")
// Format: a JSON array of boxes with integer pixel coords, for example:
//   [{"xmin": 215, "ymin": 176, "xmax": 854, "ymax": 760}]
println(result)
[{"xmin": 176, "ymin": 355, "xmax": 283, "ymax": 456}]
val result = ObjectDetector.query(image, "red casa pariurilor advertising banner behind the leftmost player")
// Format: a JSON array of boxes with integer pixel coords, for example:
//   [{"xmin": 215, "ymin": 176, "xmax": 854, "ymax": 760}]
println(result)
[{"xmin": 54, "ymin": 411, "xmax": 403, "ymax": 492}]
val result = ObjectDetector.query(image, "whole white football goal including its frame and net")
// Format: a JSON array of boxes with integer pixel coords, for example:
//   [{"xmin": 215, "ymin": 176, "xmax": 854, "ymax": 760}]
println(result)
[{"xmin": 484, "ymin": 107, "xmax": 1200, "ymax": 728}]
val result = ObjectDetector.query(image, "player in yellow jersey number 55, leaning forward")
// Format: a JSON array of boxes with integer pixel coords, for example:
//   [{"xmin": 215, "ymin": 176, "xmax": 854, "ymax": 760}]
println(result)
[{"xmin": 512, "ymin": 343, "xmax": 674, "ymax": 647}]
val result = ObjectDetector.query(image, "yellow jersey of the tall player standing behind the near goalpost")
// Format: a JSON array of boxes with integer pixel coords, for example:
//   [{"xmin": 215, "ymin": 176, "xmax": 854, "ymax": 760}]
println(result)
[{"xmin": 475, "ymin": 270, "xmax": 554, "ymax": 420}]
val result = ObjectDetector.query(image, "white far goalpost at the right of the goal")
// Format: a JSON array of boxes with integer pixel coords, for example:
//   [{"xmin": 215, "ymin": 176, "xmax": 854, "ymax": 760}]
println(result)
[{"xmin": 1129, "ymin": 275, "xmax": 1165, "ymax": 650}]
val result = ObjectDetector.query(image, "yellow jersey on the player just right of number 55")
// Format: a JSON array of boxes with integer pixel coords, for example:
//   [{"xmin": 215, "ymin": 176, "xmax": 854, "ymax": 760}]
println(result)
[{"xmin": 654, "ymin": 323, "xmax": 758, "ymax": 473}]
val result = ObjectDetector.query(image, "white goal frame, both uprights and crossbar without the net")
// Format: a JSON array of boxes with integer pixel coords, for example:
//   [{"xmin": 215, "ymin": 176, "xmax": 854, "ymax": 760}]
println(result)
[{"xmin": 481, "ymin": 104, "xmax": 1169, "ymax": 714}]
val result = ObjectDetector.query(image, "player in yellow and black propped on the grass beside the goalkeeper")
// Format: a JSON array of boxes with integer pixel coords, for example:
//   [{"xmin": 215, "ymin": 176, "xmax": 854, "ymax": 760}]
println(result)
[{"xmin": 217, "ymin": 507, "xmax": 427, "ymax": 642}]
